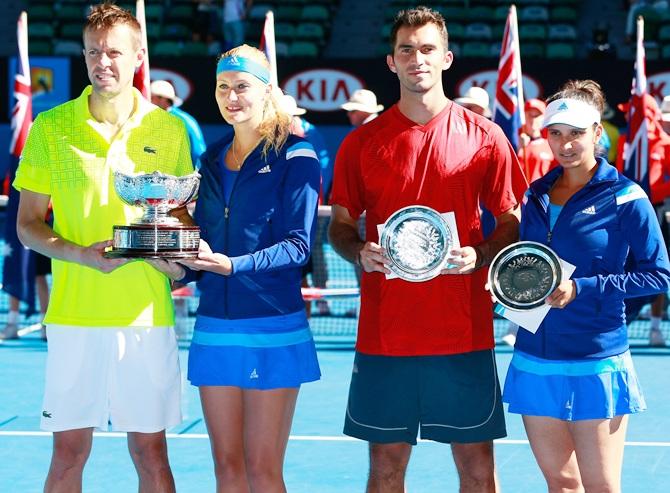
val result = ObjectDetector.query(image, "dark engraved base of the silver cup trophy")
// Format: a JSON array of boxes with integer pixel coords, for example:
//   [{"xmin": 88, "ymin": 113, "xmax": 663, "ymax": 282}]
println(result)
[{"xmin": 104, "ymin": 224, "xmax": 200, "ymax": 259}]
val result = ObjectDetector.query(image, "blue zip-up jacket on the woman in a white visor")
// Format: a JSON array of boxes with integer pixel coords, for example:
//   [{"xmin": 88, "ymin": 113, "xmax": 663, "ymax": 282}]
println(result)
[{"xmin": 515, "ymin": 158, "xmax": 670, "ymax": 360}]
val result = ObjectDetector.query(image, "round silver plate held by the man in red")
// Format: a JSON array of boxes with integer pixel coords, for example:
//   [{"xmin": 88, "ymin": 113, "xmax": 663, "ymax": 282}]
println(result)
[{"xmin": 380, "ymin": 205, "xmax": 453, "ymax": 282}]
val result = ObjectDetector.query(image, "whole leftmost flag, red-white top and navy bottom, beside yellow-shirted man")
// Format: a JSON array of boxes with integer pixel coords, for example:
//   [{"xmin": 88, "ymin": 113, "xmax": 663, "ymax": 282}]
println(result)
[{"xmin": 2, "ymin": 12, "xmax": 35, "ymax": 315}]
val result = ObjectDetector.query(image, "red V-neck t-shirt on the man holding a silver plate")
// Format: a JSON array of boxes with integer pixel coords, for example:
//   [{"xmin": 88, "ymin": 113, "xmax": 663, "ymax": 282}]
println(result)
[{"xmin": 332, "ymin": 101, "xmax": 527, "ymax": 356}]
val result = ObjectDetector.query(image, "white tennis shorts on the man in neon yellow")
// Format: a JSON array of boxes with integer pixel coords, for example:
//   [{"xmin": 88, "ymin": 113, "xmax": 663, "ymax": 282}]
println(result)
[{"xmin": 41, "ymin": 325, "xmax": 181, "ymax": 433}]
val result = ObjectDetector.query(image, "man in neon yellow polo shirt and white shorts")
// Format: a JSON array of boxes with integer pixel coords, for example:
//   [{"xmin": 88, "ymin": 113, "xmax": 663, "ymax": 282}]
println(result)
[{"xmin": 14, "ymin": 4, "xmax": 192, "ymax": 492}]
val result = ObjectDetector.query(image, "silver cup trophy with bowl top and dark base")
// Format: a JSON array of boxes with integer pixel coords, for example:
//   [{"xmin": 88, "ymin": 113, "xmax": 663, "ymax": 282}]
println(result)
[{"xmin": 105, "ymin": 171, "xmax": 200, "ymax": 258}]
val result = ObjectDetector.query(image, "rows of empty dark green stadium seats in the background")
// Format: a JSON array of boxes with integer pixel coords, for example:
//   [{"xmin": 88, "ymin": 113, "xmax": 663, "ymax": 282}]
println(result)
[{"xmin": 17, "ymin": 0, "xmax": 608, "ymax": 58}]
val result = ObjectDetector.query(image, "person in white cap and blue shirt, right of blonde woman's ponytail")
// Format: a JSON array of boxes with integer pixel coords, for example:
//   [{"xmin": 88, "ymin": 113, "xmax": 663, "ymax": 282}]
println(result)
[{"xmin": 278, "ymin": 91, "xmax": 333, "ymax": 317}]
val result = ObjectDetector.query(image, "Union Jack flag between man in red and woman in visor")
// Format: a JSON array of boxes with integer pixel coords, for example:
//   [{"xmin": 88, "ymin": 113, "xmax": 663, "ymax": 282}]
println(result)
[{"xmin": 493, "ymin": 5, "xmax": 525, "ymax": 150}]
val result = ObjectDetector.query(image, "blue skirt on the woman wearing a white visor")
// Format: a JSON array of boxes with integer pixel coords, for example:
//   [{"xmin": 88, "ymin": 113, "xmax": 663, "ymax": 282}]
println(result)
[{"xmin": 503, "ymin": 350, "xmax": 647, "ymax": 421}]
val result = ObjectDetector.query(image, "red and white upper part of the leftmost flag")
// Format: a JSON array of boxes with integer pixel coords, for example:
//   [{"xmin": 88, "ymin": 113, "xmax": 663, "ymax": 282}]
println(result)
[{"xmin": 9, "ymin": 12, "xmax": 33, "ymax": 158}]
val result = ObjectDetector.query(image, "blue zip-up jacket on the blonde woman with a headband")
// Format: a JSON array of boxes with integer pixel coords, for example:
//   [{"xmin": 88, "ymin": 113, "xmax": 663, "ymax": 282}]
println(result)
[{"xmin": 186, "ymin": 134, "xmax": 320, "ymax": 319}]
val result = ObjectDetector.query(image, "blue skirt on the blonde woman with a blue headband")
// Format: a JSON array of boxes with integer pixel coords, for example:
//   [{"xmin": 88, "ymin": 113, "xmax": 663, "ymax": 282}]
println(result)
[{"xmin": 188, "ymin": 311, "xmax": 321, "ymax": 390}]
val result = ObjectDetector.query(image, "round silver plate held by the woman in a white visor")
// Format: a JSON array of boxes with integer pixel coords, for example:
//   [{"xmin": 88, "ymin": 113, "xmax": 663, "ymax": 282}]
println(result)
[{"xmin": 489, "ymin": 241, "xmax": 561, "ymax": 311}]
